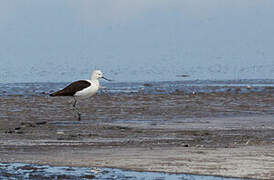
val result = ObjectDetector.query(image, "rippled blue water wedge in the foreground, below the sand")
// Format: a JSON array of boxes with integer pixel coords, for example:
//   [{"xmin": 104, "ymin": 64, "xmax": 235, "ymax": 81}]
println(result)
[{"xmin": 0, "ymin": 163, "xmax": 244, "ymax": 180}]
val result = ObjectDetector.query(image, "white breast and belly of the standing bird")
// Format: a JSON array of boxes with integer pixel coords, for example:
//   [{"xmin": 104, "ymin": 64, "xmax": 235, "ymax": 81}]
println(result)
[{"xmin": 74, "ymin": 80, "xmax": 99, "ymax": 98}]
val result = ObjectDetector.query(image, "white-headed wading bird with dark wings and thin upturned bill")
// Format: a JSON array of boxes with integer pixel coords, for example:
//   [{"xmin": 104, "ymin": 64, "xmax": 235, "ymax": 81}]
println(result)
[{"xmin": 50, "ymin": 70, "xmax": 112, "ymax": 121}]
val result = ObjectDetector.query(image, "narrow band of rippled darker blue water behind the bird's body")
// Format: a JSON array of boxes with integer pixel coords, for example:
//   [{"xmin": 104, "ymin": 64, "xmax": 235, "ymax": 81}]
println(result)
[{"xmin": 0, "ymin": 79, "xmax": 274, "ymax": 96}]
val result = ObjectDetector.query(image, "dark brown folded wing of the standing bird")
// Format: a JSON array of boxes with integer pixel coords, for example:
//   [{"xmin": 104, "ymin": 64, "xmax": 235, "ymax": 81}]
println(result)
[{"xmin": 50, "ymin": 80, "xmax": 90, "ymax": 96}]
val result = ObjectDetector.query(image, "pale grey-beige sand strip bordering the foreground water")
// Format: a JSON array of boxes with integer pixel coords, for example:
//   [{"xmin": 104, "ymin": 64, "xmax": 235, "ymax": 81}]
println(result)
[{"xmin": 1, "ymin": 137, "xmax": 274, "ymax": 179}]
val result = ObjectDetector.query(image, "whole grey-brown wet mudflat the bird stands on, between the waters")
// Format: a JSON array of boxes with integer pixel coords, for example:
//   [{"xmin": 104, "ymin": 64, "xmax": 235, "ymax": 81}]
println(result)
[{"xmin": 0, "ymin": 91, "xmax": 274, "ymax": 179}]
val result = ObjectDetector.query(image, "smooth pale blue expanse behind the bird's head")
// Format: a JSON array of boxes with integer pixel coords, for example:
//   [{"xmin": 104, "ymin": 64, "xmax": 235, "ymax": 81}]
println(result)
[{"xmin": 0, "ymin": 0, "xmax": 274, "ymax": 83}]
